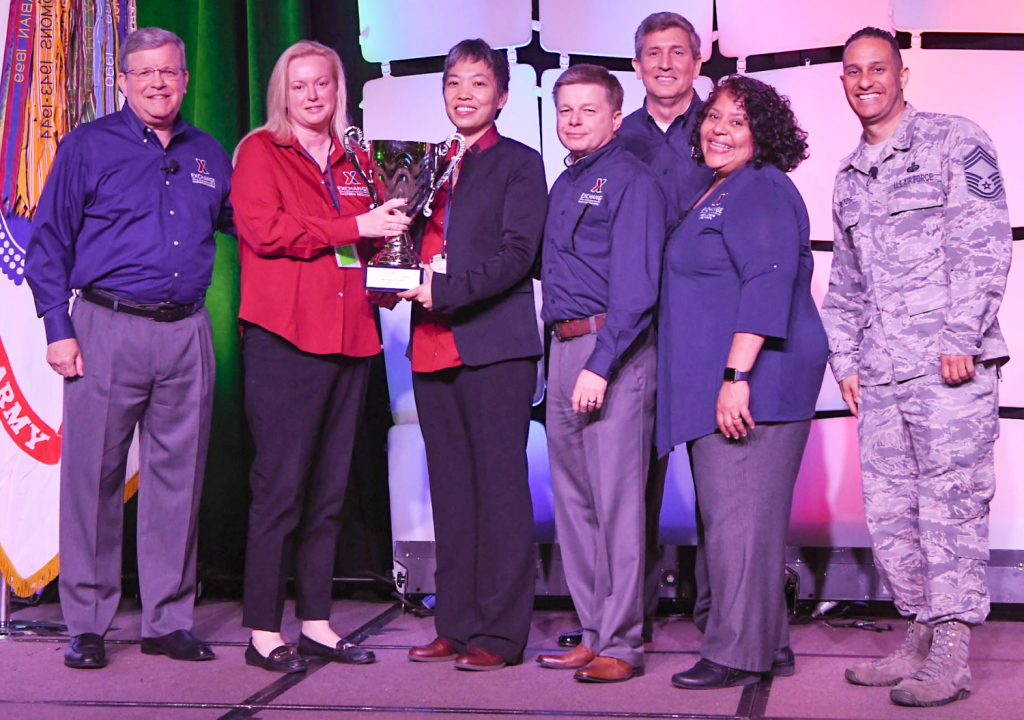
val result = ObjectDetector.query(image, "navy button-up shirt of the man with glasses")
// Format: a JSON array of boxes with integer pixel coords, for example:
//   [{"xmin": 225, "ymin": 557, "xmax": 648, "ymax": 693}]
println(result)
[{"xmin": 26, "ymin": 103, "xmax": 231, "ymax": 342}]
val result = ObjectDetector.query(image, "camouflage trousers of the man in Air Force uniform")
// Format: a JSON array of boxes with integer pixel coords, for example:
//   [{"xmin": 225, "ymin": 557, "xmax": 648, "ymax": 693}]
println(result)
[{"xmin": 857, "ymin": 366, "xmax": 998, "ymax": 625}]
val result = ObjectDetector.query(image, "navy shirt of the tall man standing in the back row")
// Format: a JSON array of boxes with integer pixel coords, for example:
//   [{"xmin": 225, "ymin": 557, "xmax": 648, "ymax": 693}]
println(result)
[{"xmin": 618, "ymin": 91, "xmax": 715, "ymax": 221}]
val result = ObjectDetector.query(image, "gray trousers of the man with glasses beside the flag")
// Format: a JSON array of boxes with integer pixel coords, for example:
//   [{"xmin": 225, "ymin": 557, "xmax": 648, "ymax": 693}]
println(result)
[{"xmin": 59, "ymin": 299, "xmax": 215, "ymax": 637}]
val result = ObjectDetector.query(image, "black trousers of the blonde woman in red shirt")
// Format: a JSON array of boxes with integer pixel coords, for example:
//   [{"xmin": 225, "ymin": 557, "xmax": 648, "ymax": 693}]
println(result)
[{"xmin": 242, "ymin": 325, "xmax": 370, "ymax": 632}]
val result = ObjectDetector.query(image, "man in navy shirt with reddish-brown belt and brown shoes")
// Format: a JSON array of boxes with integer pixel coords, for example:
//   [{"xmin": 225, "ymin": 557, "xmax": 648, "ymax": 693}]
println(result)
[{"xmin": 538, "ymin": 65, "xmax": 666, "ymax": 682}]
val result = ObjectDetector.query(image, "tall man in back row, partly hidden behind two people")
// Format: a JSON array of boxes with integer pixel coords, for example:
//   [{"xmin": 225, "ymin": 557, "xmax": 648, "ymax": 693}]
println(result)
[{"xmin": 618, "ymin": 12, "xmax": 714, "ymax": 642}]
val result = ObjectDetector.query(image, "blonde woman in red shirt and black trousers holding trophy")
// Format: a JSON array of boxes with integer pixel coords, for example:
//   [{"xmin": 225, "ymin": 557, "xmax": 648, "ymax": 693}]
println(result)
[{"xmin": 231, "ymin": 41, "xmax": 409, "ymax": 673}]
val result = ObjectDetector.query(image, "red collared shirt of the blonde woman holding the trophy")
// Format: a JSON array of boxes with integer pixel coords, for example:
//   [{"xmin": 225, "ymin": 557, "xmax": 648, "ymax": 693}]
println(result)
[{"xmin": 231, "ymin": 130, "xmax": 381, "ymax": 357}]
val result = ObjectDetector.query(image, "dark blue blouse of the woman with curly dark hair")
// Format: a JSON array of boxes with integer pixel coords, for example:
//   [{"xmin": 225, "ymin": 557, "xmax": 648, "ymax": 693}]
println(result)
[{"xmin": 655, "ymin": 165, "xmax": 828, "ymax": 455}]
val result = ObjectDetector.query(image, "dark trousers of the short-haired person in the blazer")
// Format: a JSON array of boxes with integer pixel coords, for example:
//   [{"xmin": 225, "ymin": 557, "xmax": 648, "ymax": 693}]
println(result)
[{"xmin": 413, "ymin": 359, "xmax": 537, "ymax": 664}]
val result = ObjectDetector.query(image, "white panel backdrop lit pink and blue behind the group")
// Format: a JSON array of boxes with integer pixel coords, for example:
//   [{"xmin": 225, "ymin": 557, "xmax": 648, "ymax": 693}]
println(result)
[{"xmin": 359, "ymin": 0, "xmax": 1024, "ymax": 548}]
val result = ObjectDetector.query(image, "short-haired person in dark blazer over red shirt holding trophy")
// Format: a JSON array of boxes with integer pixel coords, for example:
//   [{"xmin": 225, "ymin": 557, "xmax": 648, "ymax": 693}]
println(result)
[{"xmin": 389, "ymin": 40, "xmax": 548, "ymax": 670}]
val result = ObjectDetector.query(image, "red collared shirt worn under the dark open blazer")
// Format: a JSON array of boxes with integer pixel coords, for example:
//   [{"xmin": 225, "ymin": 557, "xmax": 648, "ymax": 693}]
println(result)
[{"xmin": 412, "ymin": 125, "xmax": 501, "ymax": 373}]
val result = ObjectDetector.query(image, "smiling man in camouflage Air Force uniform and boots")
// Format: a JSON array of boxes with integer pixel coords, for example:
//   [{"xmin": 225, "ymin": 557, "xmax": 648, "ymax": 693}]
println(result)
[{"xmin": 822, "ymin": 28, "xmax": 1012, "ymax": 706}]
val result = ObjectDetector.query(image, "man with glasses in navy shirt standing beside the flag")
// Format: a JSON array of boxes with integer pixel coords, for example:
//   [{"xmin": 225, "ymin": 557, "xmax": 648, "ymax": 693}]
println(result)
[{"xmin": 26, "ymin": 28, "xmax": 231, "ymax": 668}]
